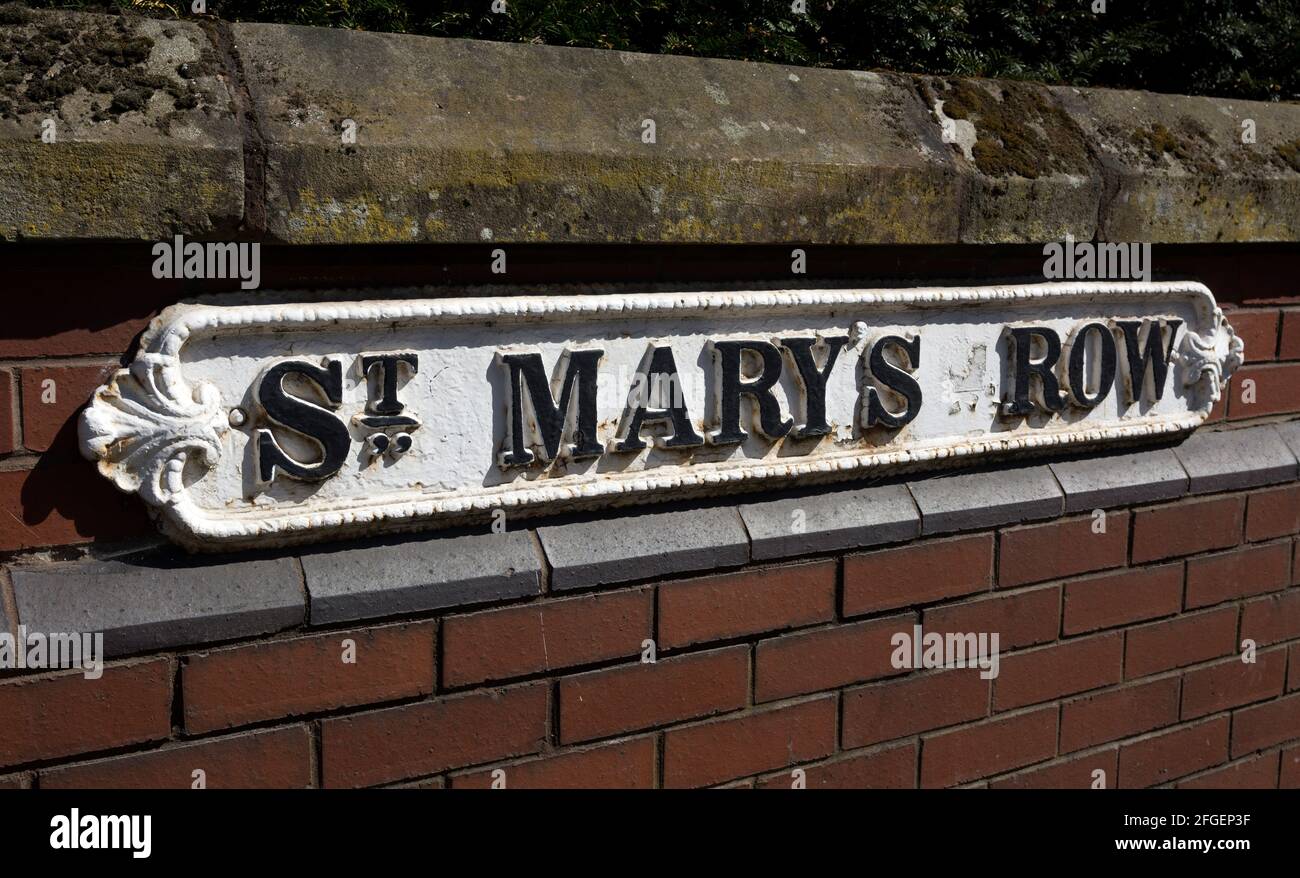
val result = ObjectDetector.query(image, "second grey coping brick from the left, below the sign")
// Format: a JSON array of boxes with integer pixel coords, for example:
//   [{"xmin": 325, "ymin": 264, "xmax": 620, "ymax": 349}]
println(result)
[{"xmin": 302, "ymin": 531, "xmax": 543, "ymax": 626}]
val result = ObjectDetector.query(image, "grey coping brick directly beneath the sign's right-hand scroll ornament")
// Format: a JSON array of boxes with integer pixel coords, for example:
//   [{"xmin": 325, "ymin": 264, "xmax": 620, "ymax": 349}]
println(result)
[{"xmin": 1175, "ymin": 425, "xmax": 1297, "ymax": 494}]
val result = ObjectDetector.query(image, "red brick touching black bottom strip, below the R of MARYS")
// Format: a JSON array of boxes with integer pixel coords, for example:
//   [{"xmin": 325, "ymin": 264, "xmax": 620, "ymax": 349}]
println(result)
[{"xmin": 663, "ymin": 695, "xmax": 837, "ymax": 788}]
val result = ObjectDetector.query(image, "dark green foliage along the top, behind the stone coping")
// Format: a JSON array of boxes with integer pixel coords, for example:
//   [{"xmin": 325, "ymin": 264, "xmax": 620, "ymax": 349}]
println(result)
[{"xmin": 17, "ymin": 0, "xmax": 1300, "ymax": 100}]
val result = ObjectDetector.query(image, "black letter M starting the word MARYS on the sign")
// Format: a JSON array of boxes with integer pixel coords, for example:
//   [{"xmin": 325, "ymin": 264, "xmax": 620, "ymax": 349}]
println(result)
[{"xmin": 497, "ymin": 350, "xmax": 605, "ymax": 467}]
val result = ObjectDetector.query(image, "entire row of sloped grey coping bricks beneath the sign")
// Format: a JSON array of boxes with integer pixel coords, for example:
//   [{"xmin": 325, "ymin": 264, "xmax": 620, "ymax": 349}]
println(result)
[{"xmin": 0, "ymin": 420, "xmax": 1300, "ymax": 656}]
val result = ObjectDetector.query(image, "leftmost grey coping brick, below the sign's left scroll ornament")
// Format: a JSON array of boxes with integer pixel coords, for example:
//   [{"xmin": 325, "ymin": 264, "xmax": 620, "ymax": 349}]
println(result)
[{"xmin": 10, "ymin": 558, "xmax": 307, "ymax": 657}]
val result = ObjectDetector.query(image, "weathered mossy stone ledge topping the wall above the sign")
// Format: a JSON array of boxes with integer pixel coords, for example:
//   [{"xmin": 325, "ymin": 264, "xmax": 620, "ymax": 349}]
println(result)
[{"xmin": 0, "ymin": 12, "xmax": 1300, "ymax": 245}]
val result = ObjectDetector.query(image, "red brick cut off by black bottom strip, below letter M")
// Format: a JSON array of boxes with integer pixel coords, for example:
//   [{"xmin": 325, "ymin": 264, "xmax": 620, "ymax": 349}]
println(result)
[{"xmin": 451, "ymin": 736, "xmax": 655, "ymax": 790}]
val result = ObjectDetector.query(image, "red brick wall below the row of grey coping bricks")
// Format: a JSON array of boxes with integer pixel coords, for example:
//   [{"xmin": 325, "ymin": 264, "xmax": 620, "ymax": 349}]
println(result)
[{"xmin": 0, "ymin": 473, "xmax": 1300, "ymax": 787}]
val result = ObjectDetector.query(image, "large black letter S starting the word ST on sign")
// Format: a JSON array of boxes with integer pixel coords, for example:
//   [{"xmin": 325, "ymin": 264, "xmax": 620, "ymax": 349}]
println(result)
[{"xmin": 254, "ymin": 359, "xmax": 352, "ymax": 484}]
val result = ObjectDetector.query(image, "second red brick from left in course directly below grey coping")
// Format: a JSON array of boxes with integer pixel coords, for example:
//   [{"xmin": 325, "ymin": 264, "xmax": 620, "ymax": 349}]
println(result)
[{"xmin": 181, "ymin": 624, "xmax": 434, "ymax": 732}]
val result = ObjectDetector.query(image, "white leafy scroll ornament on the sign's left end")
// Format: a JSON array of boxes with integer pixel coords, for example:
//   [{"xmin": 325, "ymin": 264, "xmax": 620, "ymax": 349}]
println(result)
[{"xmin": 81, "ymin": 353, "xmax": 229, "ymax": 506}]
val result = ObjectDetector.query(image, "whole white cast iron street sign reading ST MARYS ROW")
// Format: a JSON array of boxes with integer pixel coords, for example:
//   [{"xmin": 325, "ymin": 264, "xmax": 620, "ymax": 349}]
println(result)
[{"xmin": 81, "ymin": 282, "xmax": 1242, "ymax": 549}]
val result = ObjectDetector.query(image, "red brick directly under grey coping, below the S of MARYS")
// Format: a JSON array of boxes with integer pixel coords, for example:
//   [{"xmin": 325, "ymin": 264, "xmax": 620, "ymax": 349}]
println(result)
[{"xmin": 844, "ymin": 533, "xmax": 993, "ymax": 615}]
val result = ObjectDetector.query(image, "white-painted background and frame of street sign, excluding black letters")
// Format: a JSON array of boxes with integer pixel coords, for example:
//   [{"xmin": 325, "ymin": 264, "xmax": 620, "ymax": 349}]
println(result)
[{"xmin": 81, "ymin": 282, "xmax": 1242, "ymax": 549}]
